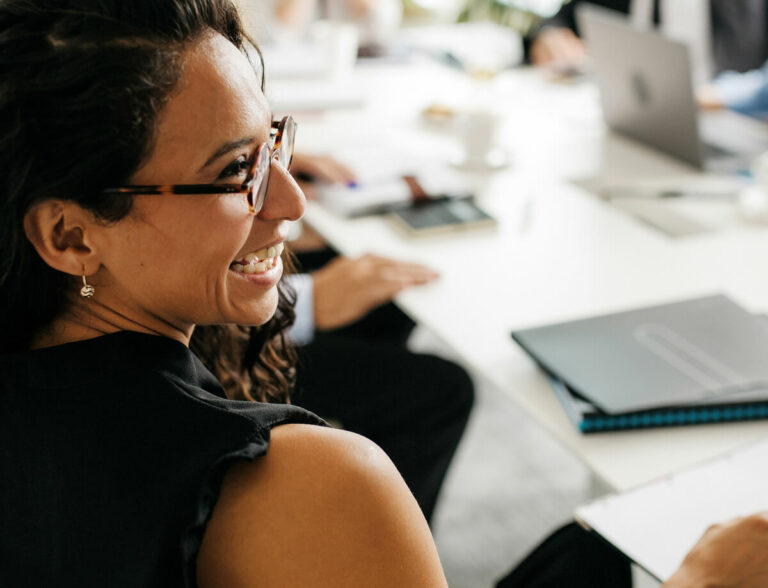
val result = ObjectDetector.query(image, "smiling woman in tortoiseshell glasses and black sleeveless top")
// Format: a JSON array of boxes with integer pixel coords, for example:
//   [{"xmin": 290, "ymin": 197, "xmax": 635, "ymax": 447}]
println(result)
[{"xmin": 0, "ymin": 0, "xmax": 768, "ymax": 588}]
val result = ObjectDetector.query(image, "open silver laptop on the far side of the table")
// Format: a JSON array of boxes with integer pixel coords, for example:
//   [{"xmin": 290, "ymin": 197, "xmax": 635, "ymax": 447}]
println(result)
[{"xmin": 576, "ymin": 4, "xmax": 768, "ymax": 171}]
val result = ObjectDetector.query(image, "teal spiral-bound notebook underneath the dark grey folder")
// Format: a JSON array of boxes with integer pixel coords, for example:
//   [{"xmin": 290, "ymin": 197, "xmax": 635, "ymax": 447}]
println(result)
[{"xmin": 552, "ymin": 378, "xmax": 768, "ymax": 433}]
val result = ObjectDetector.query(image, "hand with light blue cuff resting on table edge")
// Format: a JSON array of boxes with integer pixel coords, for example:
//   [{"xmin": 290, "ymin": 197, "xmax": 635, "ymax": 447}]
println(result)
[{"xmin": 312, "ymin": 255, "xmax": 438, "ymax": 330}]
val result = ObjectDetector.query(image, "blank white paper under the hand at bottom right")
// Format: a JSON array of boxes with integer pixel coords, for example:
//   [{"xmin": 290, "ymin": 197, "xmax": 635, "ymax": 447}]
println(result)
[{"xmin": 575, "ymin": 439, "xmax": 768, "ymax": 581}]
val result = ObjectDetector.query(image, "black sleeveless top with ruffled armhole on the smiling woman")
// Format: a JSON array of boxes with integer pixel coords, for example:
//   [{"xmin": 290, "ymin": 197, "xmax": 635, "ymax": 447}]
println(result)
[{"xmin": 0, "ymin": 332, "xmax": 323, "ymax": 588}]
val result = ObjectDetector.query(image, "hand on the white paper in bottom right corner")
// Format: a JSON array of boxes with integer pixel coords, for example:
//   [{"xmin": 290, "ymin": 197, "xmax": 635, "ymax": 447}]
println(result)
[{"xmin": 662, "ymin": 512, "xmax": 768, "ymax": 588}]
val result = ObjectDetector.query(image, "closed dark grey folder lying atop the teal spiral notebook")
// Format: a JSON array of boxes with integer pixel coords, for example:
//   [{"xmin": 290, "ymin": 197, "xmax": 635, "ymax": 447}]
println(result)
[{"xmin": 512, "ymin": 295, "xmax": 768, "ymax": 415}]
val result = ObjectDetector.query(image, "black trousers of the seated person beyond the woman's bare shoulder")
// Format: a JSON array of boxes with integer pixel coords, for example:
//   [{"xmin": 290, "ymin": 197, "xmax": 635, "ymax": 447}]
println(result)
[{"xmin": 293, "ymin": 246, "xmax": 474, "ymax": 521}]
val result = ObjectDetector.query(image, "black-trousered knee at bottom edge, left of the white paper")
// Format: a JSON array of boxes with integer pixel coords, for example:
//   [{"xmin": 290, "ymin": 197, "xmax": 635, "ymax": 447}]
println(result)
[{"xmin": 496, "ymin": 523, "xmax": 632, "ymax": 588}]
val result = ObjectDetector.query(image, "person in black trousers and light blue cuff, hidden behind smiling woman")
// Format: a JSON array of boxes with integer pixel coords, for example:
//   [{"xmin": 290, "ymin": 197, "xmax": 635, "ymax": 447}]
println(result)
[{"xmin": 282, "ymin": 153, "xmax": 474, "ymax": 523}]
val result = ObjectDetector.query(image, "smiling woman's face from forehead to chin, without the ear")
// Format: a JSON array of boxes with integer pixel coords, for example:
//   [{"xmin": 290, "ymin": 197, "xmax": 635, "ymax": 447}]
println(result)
[{"xmin": 91, "ymin": 34, "xmax": 304, "ymax": 337}]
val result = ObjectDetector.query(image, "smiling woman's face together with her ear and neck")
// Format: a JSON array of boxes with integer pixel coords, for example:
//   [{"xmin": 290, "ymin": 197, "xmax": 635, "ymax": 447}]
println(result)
[{"xmin": 19, "ymin": 32, "xmax": 296, "ymax": 347}]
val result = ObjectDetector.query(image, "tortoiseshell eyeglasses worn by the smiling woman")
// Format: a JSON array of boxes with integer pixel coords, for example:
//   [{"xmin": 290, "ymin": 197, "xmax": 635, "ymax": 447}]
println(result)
[{"xmin": 102, "ymin": 116, "xmax": 297, "ymax": 214}]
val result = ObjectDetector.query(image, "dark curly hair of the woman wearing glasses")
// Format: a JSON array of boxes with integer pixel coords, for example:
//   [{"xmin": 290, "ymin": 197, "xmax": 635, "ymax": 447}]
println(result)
[{"xmin": 0, "ymin": 0, "xmax": 295, "ymax": 401}]
